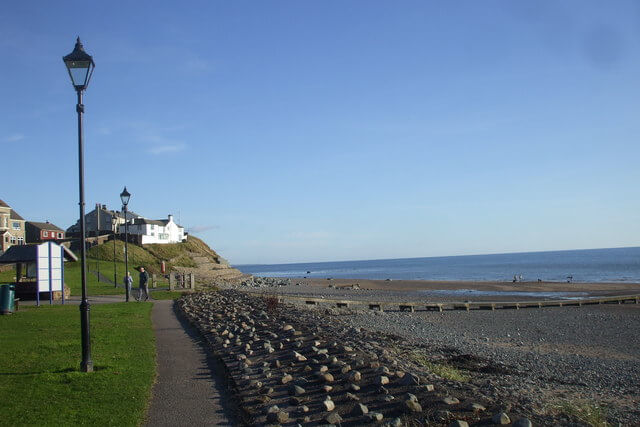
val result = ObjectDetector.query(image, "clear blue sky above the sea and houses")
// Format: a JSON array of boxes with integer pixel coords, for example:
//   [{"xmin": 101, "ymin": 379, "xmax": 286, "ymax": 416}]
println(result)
[{"xmin": 0, "ymin": 0, "xmax": 640, "ymax": 264}]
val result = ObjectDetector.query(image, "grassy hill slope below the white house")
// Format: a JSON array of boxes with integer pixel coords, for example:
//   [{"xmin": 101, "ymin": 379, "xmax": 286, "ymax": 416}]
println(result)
[{"xmin": 87, "ymin": 235, "xmax": 224, "ymax": 273}]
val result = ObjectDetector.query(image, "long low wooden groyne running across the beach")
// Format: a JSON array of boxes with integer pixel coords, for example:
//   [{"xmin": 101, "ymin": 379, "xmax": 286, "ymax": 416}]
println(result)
[{"xmin": 248, "ymin": 294, "xmax": 640, "ymax": 312}]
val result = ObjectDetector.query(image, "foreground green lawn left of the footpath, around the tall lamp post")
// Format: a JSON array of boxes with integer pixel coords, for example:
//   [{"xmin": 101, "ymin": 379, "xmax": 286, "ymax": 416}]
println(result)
[{"xmin": 0, "ymin": 303, "xmax": 155, "ymax": 426}]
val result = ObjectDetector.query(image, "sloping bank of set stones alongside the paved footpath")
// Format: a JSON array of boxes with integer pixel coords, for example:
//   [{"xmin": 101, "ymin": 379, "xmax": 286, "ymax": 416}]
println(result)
[{"xmin": 178, "ymin": 290, "xmax": 561, "ymax": 426}]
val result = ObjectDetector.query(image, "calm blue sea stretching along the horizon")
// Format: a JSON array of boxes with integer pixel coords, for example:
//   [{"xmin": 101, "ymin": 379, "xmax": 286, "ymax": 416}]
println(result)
[{"xmin": 236, "ymin": 247, "xmax": 640, "ymax": 282}]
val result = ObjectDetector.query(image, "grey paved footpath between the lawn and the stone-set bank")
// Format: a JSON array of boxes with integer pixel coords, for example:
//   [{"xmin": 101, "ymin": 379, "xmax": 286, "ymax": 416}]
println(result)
[{"xmin": 145, "ymin": 300, "xmax": 239, "ymax": 426}]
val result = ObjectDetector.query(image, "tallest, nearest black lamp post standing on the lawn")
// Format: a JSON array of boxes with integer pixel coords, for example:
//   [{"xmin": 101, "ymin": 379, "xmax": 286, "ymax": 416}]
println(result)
[{"xmin": 62, "ymin": 37, "xmax": 95, "ymax": 372}]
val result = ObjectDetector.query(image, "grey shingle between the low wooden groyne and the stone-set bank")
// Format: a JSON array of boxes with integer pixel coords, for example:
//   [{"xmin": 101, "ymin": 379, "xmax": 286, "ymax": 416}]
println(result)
[{"xmin": 344, "ymin": 305, "xmax": 640, "ymax": 424}]
